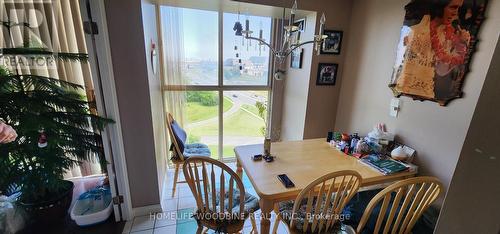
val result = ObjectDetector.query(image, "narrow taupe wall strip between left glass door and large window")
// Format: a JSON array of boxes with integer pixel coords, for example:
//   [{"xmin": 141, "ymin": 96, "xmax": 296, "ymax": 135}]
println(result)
[{"xmin": 104, "ymin": 0, "xmax": 160, "ymax": 208}]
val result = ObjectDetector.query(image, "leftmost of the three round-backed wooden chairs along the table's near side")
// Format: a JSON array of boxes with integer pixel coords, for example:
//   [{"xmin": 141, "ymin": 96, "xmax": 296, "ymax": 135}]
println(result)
[{"xmin": 182, "ymin": 157, "xmax": 259, "ymax": 233}]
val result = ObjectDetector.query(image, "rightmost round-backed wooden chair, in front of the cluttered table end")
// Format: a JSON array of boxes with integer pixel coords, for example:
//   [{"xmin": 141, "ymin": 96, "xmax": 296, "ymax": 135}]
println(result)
[{"xmin": 356, "ymin": 176, "xmax": 443, "ymax": 233}]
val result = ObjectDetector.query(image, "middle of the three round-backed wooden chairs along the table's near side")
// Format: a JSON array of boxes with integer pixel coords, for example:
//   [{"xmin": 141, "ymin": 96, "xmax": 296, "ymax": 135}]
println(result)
[{"xmin": 273, "ymin": 170, "xmax": 361, "ymax": 233}]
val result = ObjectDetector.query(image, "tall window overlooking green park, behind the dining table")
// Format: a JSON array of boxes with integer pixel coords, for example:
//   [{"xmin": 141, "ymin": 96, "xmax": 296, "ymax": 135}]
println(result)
[{"xmin": 160, "ymin": 6, "xmax": 271, "ymax": 160}]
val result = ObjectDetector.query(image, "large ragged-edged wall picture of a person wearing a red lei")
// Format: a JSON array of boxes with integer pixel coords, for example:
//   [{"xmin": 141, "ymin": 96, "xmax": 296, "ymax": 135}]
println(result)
[{"xmin": 389, "ymin": 0, "xmax": 488, "ymax": 106}]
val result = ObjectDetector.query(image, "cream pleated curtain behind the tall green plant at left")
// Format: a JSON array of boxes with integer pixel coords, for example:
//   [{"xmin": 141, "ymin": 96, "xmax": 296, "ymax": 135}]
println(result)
[{"xmin": 0, "ymin": 0, "xmax": 102, "ymax": 178}]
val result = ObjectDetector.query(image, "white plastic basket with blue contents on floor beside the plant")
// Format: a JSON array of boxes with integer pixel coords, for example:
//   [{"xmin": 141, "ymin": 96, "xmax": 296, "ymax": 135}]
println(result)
[{"xmin": 70, "ymin": 186, "xmax": 113, "ymax": 226}]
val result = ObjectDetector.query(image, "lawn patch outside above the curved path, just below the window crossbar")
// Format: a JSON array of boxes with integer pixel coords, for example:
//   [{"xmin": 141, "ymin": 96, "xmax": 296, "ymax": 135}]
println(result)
[{"xmin": 186, "ymin": 97, "xmax": 233, "ymax": 123}]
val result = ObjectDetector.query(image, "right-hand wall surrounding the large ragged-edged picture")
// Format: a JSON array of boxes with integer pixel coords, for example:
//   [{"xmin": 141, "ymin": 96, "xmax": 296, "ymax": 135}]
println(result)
[{"xmin": 335, "ymin": 0, "xmax": 500, "ymax": 190}]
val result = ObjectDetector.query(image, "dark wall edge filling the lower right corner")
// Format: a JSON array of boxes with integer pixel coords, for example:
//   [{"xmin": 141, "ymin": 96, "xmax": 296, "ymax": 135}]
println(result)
[{"xmin": 436, "ymin": 37, "xmax": 500, "ymax": 233}]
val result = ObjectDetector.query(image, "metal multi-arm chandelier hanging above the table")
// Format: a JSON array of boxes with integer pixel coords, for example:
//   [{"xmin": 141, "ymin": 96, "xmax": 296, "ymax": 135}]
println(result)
[{"xmin": 233, "ymin": 0, "xmax": 328, "ymax": 64}]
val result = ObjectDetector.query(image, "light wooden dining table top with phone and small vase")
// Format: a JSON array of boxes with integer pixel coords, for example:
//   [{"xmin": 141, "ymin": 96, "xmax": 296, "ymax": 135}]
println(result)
[{"xmin": 234, "ymin": 138, "xmax": 416, "ymax": 199}]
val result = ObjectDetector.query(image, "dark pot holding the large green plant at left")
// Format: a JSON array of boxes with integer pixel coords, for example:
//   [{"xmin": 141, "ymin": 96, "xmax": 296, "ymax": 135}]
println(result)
[{"xmin": 19, "ymin": 180, "xmax": 75, "ymax": 226}]
